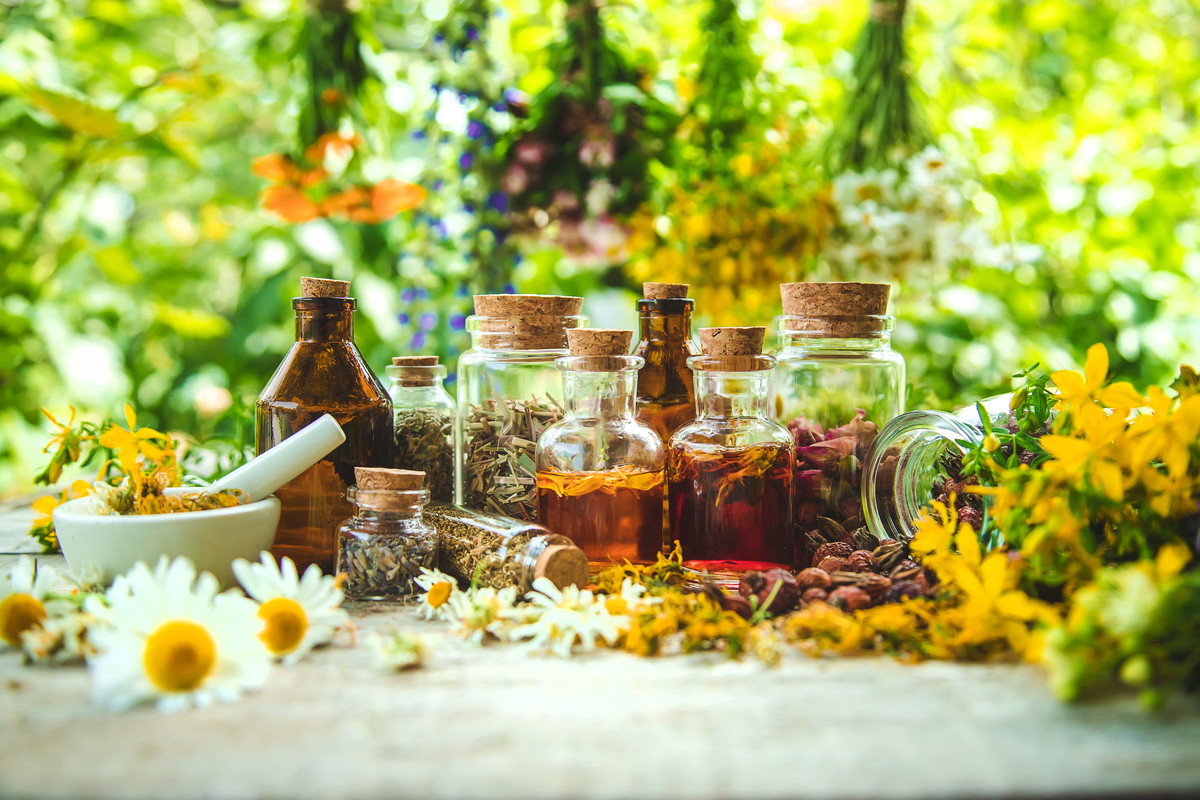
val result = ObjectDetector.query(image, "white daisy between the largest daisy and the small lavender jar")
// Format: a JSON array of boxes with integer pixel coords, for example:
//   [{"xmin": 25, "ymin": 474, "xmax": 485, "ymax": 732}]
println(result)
[{"xmin": 233, "ymin": 551, "xmax": 350, "ymax": 664}]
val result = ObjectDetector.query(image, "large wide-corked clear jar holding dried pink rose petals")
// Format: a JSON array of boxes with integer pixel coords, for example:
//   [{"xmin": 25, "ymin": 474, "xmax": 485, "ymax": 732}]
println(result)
[{"xmin": 770, "ymin": 283, "xmax": 905, "ymax": 566}]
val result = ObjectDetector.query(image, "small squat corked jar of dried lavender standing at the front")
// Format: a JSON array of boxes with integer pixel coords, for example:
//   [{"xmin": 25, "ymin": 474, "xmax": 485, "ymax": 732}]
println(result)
[{"xmin": 337, "ymin": 467, "xmax": 438, "ymax": 600}]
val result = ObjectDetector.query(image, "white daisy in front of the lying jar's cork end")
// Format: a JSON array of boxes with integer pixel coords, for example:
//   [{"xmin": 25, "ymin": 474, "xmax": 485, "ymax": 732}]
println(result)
[{"xmin": 511, "ymin": 578, "xmax": 632, "ymax": 657}]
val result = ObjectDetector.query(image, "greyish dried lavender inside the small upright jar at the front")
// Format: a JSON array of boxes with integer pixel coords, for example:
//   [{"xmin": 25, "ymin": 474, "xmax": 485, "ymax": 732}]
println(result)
[{"xmin": 337, "ymin": 534, "xmax": 438, "ymax": 599}]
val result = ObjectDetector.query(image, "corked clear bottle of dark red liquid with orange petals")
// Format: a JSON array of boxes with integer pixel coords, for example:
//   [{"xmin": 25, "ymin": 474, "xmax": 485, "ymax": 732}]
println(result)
[{"xmin": 667, "ymin": 327, "xmax": 794, "ymax": 588}]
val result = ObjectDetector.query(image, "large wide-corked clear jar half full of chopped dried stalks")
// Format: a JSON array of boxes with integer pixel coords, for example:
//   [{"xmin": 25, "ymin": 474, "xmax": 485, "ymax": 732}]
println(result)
[{"xmin": 455, "ymin": 295, "xmax": 587, "ymax": 522}]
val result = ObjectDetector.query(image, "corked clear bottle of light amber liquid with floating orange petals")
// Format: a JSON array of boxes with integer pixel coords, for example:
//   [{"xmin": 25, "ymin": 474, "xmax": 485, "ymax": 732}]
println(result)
[{"xmin": 538, "ymin": 327, "xmax": 666, "ymax": 572}]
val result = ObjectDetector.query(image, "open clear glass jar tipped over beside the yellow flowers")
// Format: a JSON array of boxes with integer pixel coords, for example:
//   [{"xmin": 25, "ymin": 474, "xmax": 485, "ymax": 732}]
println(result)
[{"xmin": 863, "ymin": 393, "xmax": 1013, "ymax": 546}]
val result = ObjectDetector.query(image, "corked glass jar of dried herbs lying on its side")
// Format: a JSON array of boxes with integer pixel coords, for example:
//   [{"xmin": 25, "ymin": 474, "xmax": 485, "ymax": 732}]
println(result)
[{"xmin": 425, "ymin": 504, "xmax": 588, "ymax": 593}]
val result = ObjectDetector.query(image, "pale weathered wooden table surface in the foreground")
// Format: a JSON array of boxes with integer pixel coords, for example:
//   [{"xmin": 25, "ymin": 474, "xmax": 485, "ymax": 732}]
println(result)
[{"xmin": 0, "ymin": 503, "xmax": 1200, "ymax": 799}]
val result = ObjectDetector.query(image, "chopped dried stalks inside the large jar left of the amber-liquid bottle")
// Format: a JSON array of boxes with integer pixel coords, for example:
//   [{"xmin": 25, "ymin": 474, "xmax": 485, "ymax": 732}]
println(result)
[{"xmin": 463, "ymin": 395, "xmax": 563, "ymax": 522}]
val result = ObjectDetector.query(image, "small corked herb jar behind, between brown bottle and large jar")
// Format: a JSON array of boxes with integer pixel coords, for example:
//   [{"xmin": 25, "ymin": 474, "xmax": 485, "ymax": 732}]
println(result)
[{"xmin": 386, "ymin": 355, "xmax": 454, "ymax": 503}]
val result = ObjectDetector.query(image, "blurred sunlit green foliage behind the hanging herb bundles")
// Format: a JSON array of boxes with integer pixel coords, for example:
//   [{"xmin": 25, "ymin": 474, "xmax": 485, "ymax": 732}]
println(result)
[{"xmin": 0, "ymin": 0, "xmax": 1200, "ymax": 495}]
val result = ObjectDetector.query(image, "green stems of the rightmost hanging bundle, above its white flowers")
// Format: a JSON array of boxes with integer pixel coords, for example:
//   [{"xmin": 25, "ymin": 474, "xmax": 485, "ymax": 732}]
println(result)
[{"xmin": 821, "ymin": 0, "xmax": 929, "ymax": 175}]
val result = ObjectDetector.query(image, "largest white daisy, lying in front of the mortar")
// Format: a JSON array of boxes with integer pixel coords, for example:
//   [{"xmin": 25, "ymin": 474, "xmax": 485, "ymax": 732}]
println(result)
[{"xmin": 85, "ymin": 557, "xmax": 271, "ymax": 711}]
